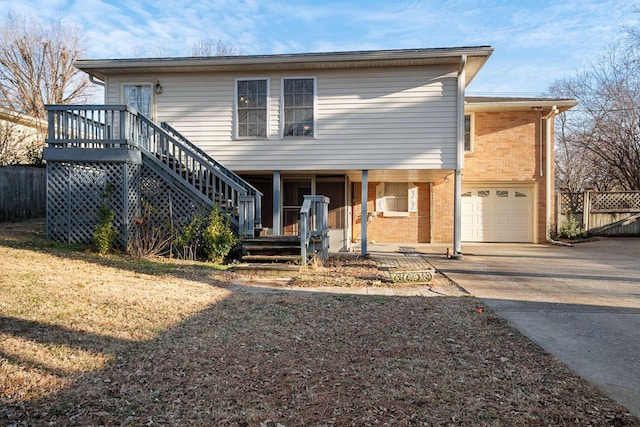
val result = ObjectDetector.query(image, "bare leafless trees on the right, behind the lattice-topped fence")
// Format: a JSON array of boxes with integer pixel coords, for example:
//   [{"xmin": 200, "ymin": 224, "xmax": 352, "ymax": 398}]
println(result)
[{"xmin": 550, "ymin": 38, "xmax": 640, "ymax": 190}]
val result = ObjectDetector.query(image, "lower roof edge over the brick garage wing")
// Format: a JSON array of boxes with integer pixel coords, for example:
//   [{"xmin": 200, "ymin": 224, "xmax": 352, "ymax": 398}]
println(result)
[{"xmin": 464, "ymin": 96, "xmax": 578, "ymax": 112}]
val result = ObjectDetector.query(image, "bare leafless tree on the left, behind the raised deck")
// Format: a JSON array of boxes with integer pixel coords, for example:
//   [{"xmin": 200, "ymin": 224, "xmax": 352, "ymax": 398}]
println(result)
[{"xmin": 0, "ymin": 12, "xmax": 90, "ymax": 118}]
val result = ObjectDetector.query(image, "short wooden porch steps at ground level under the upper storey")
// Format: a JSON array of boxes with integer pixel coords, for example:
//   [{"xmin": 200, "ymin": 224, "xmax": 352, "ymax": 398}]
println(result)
[{"xmin": 235, "ymin": 236, "xmax": 302, "ymax": 277}]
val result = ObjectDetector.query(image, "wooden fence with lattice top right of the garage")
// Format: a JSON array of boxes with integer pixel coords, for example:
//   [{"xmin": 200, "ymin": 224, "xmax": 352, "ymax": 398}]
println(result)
[{"xmin": 556, "ymin": 190, "xmax": 640, "ymax": 236}]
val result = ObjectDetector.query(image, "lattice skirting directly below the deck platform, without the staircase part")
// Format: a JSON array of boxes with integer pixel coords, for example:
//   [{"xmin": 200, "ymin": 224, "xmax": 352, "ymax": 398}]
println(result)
[{"xmin": 47, "ymin": 161, "xmax": 141, "ymax": 247}]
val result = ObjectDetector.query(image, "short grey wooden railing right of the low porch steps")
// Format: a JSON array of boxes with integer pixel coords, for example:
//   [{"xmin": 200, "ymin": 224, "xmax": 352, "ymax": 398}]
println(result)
[{"xmin": 300, "ymin": 196, "xmax": 329, "ymax": 264}]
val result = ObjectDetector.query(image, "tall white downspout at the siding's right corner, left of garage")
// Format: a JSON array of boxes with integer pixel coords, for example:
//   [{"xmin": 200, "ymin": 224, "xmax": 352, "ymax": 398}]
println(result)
[{"xmin": 452, "ymin": 55, "xmax": 467, "ymax": 259}]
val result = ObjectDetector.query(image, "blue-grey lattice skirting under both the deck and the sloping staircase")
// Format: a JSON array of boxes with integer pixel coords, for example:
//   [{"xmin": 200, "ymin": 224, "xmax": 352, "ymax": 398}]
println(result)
[{"xmin": 47, "ymin": 161, "xmax": 208, "ymax": 249}]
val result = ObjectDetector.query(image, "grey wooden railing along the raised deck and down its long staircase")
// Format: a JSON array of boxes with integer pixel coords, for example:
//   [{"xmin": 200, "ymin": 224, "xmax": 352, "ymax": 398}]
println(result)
[{"xmin": 47, "ymin": 105, "xmax": 262, "ymax": 237}]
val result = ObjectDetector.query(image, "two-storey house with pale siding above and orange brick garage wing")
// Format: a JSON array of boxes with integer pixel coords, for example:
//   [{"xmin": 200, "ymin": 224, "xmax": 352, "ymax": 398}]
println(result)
[{"xmin": 42, "ymin": 46, "xmax": 576, "ymax": 255}]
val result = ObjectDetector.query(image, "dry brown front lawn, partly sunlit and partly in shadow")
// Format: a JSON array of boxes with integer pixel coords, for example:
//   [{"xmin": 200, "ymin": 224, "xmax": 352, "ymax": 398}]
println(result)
[{"xmin": 0, "ymin": 222, "xmax": 640, "ymax": 426}]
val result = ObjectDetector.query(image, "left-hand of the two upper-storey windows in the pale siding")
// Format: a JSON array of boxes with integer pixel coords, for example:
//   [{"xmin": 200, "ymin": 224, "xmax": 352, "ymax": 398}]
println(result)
[{"xmin": 236, "ymin": 79, "xmax": 269, "ymax": 138}]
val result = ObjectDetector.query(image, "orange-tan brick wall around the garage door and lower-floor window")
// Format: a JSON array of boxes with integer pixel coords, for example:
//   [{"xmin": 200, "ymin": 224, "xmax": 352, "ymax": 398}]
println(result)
[{"xmin": 352, "ymin": 110, "xmax": 554, "ymax": 243}]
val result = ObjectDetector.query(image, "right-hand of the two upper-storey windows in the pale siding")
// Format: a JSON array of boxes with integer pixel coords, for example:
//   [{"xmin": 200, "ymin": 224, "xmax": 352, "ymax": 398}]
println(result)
[{"xmin": 282, "ymin": 78, "xmax": 316, "ymax": 137}]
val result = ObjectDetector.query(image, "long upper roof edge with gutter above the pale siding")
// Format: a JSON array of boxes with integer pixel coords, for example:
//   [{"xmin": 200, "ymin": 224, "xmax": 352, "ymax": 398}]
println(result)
[{"xmin": 75, "ymin": 46, "xmax": 493, "ymax": 84}]
